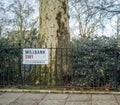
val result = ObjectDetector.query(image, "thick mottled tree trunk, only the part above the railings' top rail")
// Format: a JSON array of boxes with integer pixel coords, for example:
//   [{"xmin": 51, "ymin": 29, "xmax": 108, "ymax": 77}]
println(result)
[{"xmin": 39, "ymin": 0, "xmax": 70, "ymax": 47}]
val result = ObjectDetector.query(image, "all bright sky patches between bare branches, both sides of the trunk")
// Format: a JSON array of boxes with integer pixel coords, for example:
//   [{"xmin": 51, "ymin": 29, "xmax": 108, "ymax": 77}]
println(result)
[{"xmin": 0, "ymin": 0, "xmax": 116, "ymax": 37}]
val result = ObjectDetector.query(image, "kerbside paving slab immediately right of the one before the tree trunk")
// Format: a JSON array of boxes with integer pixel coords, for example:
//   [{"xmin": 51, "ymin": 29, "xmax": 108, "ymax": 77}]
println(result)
[{"xmin": 68, "ymin": 94, "xmax": 92, "ymax": 102}]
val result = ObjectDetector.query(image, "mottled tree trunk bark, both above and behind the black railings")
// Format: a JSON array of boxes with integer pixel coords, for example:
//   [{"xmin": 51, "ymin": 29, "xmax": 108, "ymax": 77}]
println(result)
[{"xmin": 38, "ymin": 0, "xmax": 70, "ymax": 82}]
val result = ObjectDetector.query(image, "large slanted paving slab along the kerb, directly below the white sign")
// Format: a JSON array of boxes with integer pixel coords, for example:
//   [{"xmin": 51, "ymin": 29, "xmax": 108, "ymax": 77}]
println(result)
[{"xmin": 10, "ymin": 93, "xmax": 46, "ymax": 105}]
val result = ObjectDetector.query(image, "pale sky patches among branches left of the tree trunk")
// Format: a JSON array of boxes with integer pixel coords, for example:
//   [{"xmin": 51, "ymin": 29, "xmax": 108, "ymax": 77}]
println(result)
[{"xmin": 0, "ymin": 0, "xmax": 39, "ymax": 37}]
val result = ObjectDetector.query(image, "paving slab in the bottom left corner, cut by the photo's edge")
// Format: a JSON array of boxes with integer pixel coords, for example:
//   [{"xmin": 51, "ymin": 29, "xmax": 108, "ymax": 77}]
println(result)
[{"xmin": 0, "ymin": 93, "xmax": 24, "ymax": 105}]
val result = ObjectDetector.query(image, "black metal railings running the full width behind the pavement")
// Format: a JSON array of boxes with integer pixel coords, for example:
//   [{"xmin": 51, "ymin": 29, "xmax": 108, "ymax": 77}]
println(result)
[{"xmin": 0, "ymin": 43, "xmax": 120, "ymax": 90}]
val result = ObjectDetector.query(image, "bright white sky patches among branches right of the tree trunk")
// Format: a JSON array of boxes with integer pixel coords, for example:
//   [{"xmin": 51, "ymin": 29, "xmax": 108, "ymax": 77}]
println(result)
[{"xmin": 69, "ymin": 12, "xmax": 117, "ymax": 37}]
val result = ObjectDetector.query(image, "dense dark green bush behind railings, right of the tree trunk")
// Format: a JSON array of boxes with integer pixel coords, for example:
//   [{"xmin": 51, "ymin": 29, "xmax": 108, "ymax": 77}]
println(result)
[{"xmin": 72, "ymin": 36, "xmax": 119, "ymax": 88}]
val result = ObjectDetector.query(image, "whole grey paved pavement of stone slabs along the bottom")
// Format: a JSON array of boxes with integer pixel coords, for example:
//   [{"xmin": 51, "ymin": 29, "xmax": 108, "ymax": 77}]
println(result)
[{"xmin": 0, "ymin": 92, "xmax": 120, "ymax": 105}]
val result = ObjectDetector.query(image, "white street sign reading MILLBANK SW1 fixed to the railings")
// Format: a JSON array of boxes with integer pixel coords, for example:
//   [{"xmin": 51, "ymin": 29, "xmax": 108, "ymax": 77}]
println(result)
[{"xmin": 23, "ymin": 48, "xmax": 48, "ymax": 64}]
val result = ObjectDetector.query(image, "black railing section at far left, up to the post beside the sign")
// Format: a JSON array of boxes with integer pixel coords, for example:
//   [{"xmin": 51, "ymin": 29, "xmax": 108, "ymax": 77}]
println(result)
[{"xmin": 0, "ymin": 43, "xmax": 21, "ymax": 86}]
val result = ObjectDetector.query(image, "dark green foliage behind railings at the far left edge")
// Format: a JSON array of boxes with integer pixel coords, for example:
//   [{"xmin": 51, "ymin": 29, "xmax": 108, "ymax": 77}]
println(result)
[{"xmin": 0, "ymin": 39, "xmax": 19, "ymax": 85}]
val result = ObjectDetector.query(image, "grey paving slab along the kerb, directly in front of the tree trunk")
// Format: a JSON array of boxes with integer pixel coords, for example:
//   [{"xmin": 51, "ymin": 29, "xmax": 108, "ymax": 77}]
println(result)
[{"xmin": 45, "ymin": 94, "xmax": 68, "ymax": 100}]
